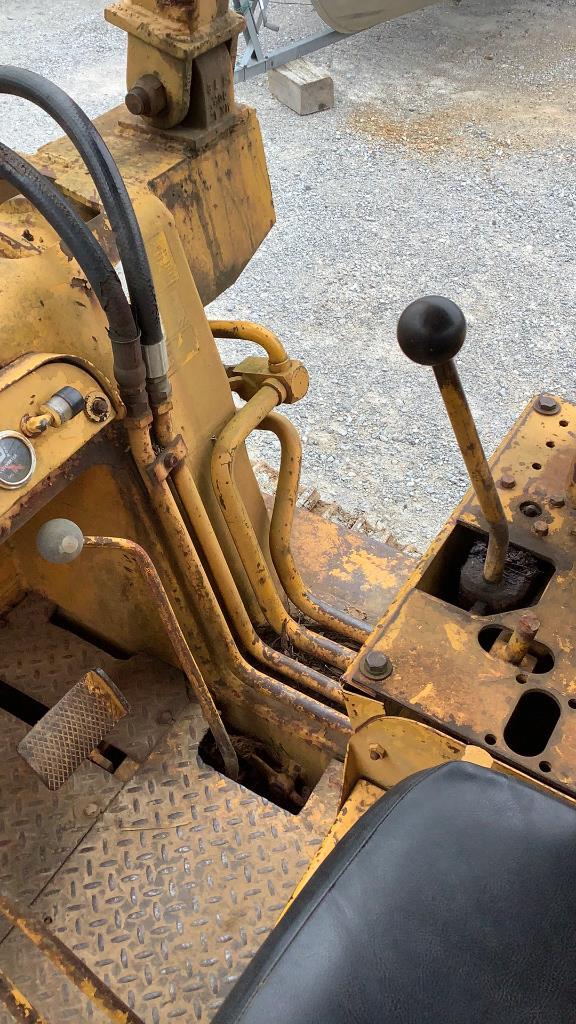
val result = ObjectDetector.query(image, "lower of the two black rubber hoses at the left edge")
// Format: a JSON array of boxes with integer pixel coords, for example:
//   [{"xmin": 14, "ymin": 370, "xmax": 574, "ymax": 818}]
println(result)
[{"xmin": 0, "ymin": 142, "xmax": 149, "ymax": 417}]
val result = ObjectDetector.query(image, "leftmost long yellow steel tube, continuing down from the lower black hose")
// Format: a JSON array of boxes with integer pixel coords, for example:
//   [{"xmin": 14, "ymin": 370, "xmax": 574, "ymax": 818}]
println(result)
[{"xmin": 126, "ymin": 421, "xmax": 351, "ymax": 750}]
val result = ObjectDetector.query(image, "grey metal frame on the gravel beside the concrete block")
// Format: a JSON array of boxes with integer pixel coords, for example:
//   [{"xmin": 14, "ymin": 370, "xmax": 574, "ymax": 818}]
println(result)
[{"xmin": 233, "ymin": 0, "xmax": 352, "ymax": 82}]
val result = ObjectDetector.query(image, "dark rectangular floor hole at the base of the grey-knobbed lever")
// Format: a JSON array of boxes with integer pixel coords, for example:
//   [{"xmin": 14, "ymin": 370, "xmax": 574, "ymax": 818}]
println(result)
[{"xmin": 198, "ymin": 731, "xmax": 313, "ymax": 814}]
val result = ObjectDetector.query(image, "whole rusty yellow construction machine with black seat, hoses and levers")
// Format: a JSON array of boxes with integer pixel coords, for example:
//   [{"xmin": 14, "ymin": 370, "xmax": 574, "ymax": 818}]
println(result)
[{"xmin": 0, "ymin": 0, "xmax": 576, "ymax": 1024}]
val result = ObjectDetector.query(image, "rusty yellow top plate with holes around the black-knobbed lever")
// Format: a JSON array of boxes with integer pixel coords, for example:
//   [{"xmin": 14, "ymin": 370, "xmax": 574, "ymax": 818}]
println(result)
[{"xmin": 340, "ymin": 402, "xmax": 576, "ymax": 795}]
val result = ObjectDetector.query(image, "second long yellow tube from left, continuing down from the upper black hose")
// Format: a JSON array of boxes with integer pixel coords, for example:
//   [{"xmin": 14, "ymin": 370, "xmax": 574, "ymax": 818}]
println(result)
[{"xmin": 155, "ymin": 412, "xmax": 345, "ymax": 708}]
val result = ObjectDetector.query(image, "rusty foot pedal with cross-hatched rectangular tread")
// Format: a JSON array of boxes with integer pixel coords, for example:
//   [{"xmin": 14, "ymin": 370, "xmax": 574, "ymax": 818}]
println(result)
[{"xmin": 18, "ymin": 669, "xmax": 130, "ymax": 790}]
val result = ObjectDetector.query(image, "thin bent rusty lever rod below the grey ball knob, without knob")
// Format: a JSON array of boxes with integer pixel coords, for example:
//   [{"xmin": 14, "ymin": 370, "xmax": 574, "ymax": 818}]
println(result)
[{"xmin": 84, "ymin": 537, "xmax": 239, "ymax": 779}]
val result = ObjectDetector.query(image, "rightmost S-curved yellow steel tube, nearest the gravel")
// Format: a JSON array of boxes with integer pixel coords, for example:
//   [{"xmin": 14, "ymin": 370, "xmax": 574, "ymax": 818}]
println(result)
[{"xmin": 260, "ymin": 413, "xmax": 371, "ymax": 643}]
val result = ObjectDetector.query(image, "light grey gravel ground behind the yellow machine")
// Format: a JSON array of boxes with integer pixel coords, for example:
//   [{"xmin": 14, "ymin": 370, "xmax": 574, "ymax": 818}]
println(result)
[{"xmin": 0, "ymin": 0, "xmax": 576, "ymax": 549}]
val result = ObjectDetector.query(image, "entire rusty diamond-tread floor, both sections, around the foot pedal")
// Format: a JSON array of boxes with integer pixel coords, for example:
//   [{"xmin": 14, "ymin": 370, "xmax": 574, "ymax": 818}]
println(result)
[{"xmin": 0, "ymin": 602, "xmax": 342, "ymax": 1024}]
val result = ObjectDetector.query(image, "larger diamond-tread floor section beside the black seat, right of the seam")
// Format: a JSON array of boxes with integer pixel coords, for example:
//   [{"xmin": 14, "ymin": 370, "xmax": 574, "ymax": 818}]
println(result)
[{"xmin": 0, "ymin": 707, "xmax": 342, "ymax": 1024}]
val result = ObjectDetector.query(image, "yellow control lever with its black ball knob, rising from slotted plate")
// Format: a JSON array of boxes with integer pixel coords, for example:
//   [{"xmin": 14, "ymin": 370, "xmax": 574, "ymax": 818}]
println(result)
[{"xmin": 397, "ymin": 295, "xmax": 508, "ymax": 584}]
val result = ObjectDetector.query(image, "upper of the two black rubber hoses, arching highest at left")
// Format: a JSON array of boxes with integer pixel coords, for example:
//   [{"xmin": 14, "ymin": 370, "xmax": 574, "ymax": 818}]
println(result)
[{"xmin": 0, "ymin": 65, "xmax": 163, "ymax": 345}]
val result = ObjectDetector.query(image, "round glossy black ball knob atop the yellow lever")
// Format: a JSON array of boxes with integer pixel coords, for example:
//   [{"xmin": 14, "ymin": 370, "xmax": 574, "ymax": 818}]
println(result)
[{"xmin": 398, "ymin": 295, "xmax": 466, "ymax": 367}]
